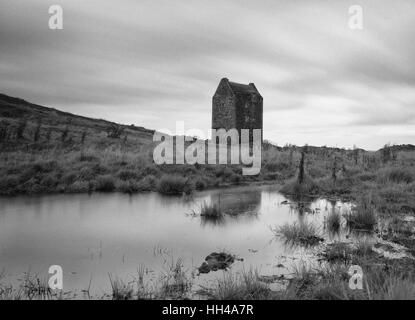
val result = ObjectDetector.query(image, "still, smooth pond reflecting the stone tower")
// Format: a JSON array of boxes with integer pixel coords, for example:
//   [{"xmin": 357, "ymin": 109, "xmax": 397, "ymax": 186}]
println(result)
[{"xmin": 0, "ymin": 186, "xmax": 350, "ymax": 296}]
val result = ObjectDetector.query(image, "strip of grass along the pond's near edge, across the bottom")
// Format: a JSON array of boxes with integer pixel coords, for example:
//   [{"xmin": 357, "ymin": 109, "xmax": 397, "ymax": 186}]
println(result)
[{"xmin": 0, "ymin": 249, "xmax": 415, "ymax": 300}]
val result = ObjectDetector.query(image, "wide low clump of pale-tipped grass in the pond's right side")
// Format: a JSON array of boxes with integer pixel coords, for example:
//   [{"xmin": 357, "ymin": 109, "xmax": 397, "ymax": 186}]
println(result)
[{"xmin": 271, "ymin": 222, "xmax": 323, "ymax": 246}]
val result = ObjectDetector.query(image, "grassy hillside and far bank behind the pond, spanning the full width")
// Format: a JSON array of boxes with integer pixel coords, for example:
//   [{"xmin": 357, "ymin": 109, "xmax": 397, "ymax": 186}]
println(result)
[{"xmin": 0, "ymin": 91, "xmax": 415, "ymax": 201}]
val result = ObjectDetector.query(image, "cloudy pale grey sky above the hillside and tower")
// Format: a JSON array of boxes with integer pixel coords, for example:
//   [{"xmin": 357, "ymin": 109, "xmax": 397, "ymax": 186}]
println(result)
[{"xmin": 0, "ymin": 0, "xmax": 415, "ymax": 149}]
